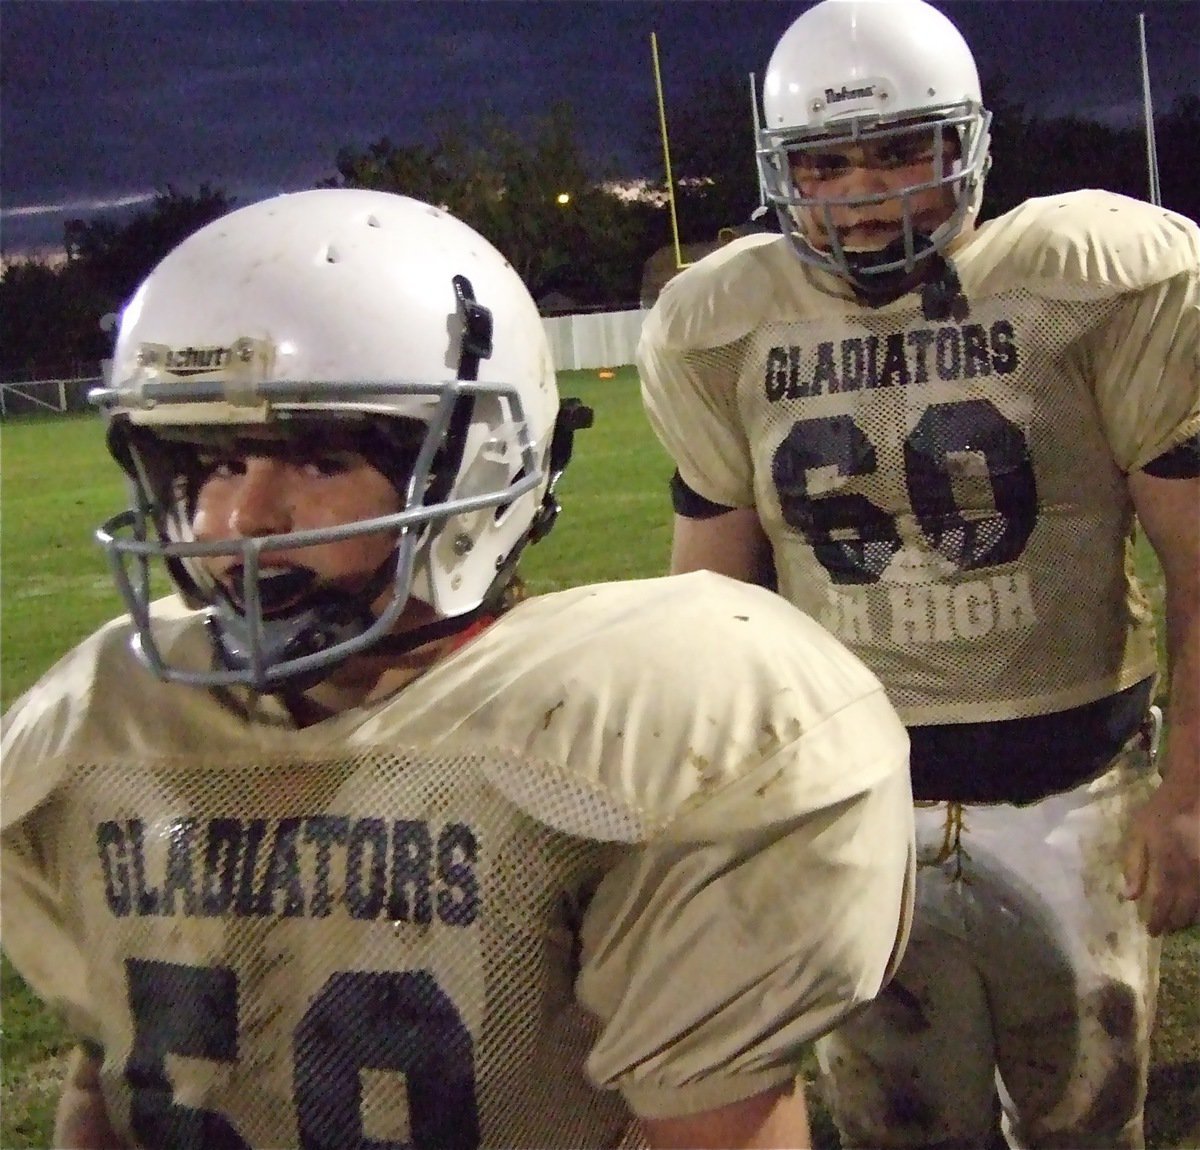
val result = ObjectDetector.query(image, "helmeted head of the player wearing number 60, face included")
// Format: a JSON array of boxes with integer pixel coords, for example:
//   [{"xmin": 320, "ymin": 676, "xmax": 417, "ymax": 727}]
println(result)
[{"xmin": 758, "ymin": 0, "xmax": 991, "ymax": 303}]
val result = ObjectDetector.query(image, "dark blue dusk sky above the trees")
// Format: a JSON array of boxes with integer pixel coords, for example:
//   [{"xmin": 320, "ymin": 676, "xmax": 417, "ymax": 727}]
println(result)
[{"xmin": 0, "ymin": 0, "xmax": 1200, "ymax": 253}]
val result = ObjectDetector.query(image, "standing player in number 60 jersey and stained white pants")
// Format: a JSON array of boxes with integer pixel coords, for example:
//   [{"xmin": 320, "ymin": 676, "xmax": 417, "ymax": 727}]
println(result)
[{"xmin": 638, "ymin": 0, "xmax": 1200, "ymax": 1148}]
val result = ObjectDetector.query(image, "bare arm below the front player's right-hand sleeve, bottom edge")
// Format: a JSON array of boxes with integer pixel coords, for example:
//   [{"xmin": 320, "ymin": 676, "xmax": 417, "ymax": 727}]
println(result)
[{"xmin": 641, "ymin": 1083, "xmax": 811, "ymax": 1150}]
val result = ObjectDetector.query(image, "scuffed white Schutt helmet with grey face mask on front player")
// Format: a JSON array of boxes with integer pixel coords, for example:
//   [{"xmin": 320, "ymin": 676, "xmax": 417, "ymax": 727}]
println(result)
[{"xmin": 94, "ymin": 188, "xmax": 590, "ymax": 691}]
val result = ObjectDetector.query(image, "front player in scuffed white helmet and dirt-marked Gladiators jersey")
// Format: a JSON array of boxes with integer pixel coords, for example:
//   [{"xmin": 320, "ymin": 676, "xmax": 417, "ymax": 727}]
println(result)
[{"xmin": 2, "ymin": 188, "xmax": 914, "ymax": 1150}]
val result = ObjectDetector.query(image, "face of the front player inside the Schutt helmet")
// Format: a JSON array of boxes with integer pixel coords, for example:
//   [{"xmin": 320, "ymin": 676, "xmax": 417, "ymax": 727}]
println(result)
[{"xmin": 192, "ymin": 438, "xmax": 401, "ymax": 611}]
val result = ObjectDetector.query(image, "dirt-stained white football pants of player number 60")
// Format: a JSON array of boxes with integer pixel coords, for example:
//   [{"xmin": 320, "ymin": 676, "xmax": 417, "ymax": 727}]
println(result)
[{"xmin": 817, "ymin": 732, "xmax": 1159, "ymax": 1150}]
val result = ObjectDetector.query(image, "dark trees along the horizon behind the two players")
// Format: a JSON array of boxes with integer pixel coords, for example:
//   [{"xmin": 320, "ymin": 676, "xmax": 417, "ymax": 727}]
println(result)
[{"xmin": 0, "ymin": 76, "xmax": 1200, "ymax": 381}]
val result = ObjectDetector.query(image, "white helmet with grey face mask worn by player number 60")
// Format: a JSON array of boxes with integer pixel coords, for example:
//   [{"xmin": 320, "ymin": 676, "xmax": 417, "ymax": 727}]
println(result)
[{"xmin": 758, "ymin": 0, "xmax": 991, "ymax": 298}]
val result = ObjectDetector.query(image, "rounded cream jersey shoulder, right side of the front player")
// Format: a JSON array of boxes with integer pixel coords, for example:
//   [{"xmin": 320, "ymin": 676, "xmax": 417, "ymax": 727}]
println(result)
[{"xmin": 404, "ymin": 571, "xmax": 908, "ymax": 841}]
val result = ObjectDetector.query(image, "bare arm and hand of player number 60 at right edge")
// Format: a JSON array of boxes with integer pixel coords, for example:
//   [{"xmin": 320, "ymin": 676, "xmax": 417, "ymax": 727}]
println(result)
[{"xmin": 1124, "ymin": 465, "xmax": 1200, "ymax": 934}]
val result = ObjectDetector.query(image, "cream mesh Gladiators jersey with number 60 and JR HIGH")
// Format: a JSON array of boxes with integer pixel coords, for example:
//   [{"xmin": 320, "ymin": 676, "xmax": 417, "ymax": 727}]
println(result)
[{"xmin": 638, "ymin": 191, "xmax": 1200, "ymax": 725}]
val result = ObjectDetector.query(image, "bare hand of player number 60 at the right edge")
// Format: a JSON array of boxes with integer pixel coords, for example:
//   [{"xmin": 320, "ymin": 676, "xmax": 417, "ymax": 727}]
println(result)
[{"xmin": 1123, "ymin": 763, "xmax": 1200, "ymax": 935}]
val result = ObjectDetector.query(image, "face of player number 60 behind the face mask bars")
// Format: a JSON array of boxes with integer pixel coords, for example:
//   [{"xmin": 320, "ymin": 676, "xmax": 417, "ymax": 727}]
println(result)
[{"xmin": 792, "ymin": 128, "xmax": 956, "ymax": 258}]
